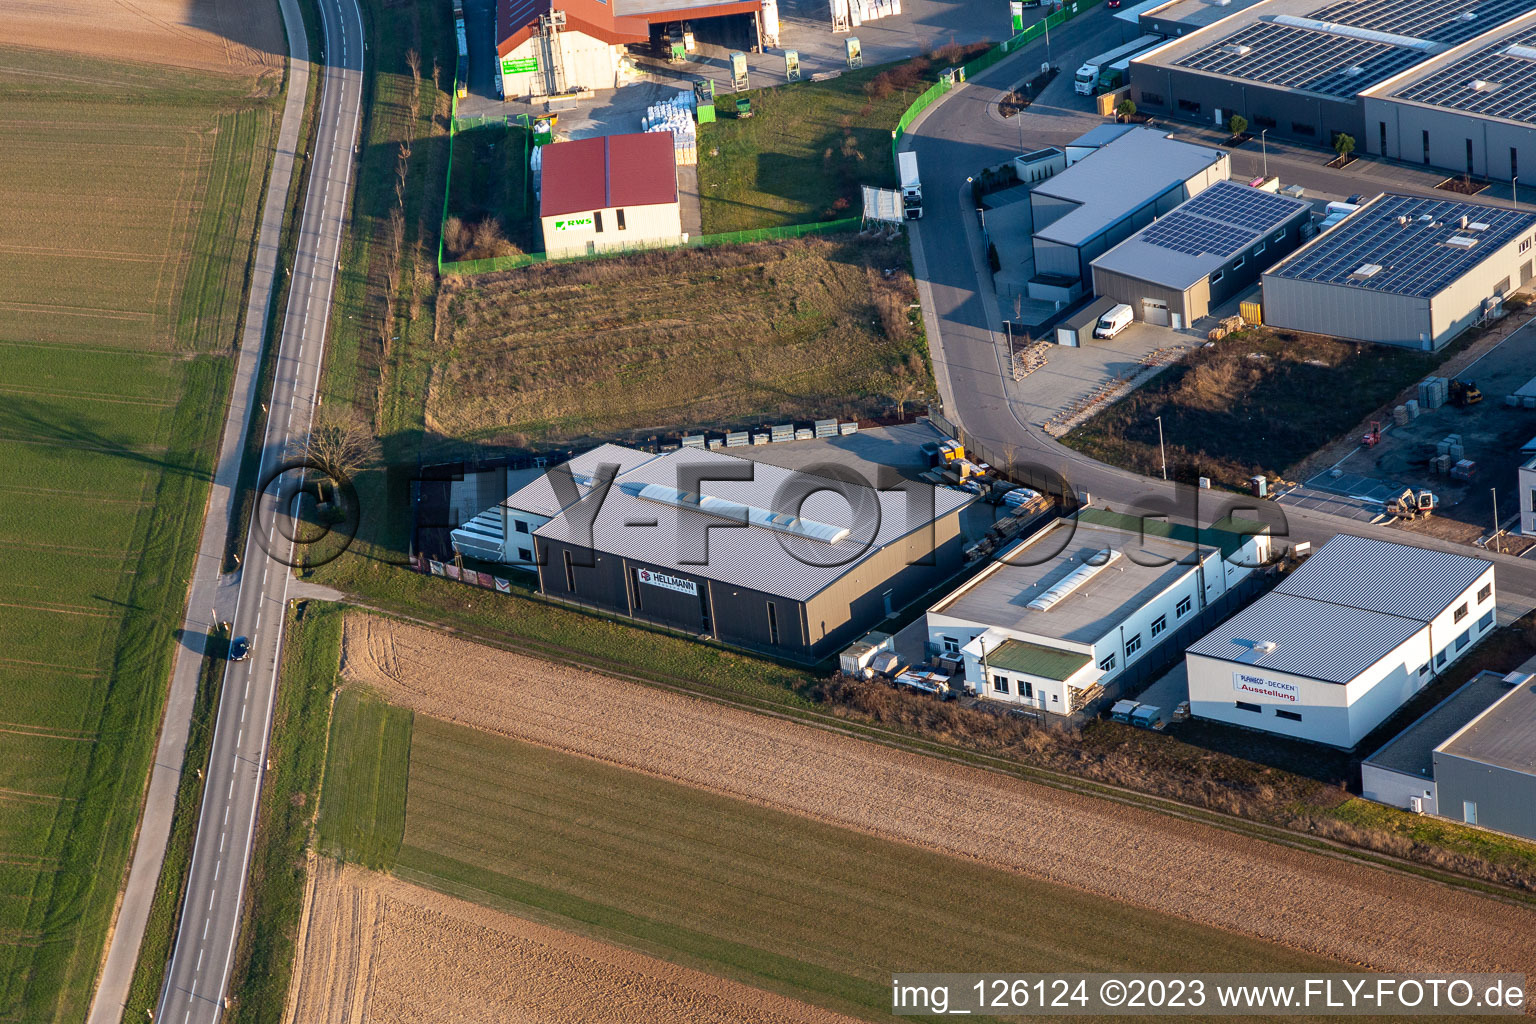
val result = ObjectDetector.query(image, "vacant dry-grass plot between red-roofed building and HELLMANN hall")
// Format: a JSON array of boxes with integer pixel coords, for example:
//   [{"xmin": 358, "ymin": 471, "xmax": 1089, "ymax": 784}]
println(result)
[{"xmin": 427, "ymin": 235, "xmax": 931, "ymax": 445}]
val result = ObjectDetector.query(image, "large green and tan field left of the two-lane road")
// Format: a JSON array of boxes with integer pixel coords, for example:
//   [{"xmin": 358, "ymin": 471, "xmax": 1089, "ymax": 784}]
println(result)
[{"xmin": 0, "ymin": 48, "xmax": 276, "ymax": 1021}]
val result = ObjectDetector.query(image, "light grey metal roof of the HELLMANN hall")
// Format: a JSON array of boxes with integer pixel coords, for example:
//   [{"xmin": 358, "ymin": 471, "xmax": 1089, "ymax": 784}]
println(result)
[{"xmin": 535, "ymin": 448, "xmax": 974, "ymax": 600}]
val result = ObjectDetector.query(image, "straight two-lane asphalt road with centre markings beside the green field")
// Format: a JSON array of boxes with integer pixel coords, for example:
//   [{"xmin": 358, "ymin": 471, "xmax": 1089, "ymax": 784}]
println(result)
[{"xmin": 155, "ymin": 0, "xmax": 364, "ymax": 1024}]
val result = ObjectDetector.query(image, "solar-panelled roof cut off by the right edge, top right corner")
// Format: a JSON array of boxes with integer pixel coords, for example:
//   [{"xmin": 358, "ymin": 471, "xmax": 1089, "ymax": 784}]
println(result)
[{"xmin": 1392, "ymin": 14, "xmax": 1536, "ymax": 124}]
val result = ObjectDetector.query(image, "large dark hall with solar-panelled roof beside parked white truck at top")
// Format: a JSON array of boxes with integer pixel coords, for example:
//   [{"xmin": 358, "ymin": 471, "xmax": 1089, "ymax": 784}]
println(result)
[{"xmin": 1130, "ymin": 0, "xmax": 1530, "ymax": 165}]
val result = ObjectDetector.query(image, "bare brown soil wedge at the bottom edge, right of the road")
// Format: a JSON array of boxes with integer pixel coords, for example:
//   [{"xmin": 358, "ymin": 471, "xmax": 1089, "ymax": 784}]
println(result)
[{"xmin": 284, "ymin": 858, "xmax": 852, "ymax": 1024}]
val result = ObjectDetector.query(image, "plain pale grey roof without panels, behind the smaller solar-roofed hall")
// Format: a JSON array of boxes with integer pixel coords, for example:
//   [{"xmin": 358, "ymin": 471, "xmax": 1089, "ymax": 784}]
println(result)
[{"xmin": 1034, "ymin": 127, "xmax": 1226, "ymax": 246}]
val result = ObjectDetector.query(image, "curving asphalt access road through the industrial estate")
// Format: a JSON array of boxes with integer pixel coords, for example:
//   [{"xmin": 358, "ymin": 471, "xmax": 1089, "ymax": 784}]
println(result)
[{"xmin": 902, "ymin": 9, "xmax": 1536, "ymax": 616}]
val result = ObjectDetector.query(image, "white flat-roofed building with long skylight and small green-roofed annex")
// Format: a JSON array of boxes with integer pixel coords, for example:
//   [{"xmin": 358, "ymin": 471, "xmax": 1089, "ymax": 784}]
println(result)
[{"xmin": 926, "ymin": 508, "xmax": 1270, "ymax": 714}]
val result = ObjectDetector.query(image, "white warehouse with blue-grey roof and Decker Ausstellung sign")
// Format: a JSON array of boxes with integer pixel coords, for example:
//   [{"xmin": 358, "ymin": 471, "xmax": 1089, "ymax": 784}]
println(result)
[{"xmin": 1186, "ymin": 534, "xmax": 1496, "ymax": 749}]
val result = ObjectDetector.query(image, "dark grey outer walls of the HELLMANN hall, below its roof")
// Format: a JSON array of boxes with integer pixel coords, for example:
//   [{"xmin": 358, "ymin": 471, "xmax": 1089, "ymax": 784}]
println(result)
[{"xmin": 535, "ymin": 510, "xmax": 965, "ymax": 662}]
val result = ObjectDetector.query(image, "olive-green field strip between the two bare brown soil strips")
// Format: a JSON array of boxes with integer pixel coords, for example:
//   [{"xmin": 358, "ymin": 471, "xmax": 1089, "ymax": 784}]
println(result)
[{"xmin": 321, "ymin": 702, "xmax": 1338, "ymax": 1019}]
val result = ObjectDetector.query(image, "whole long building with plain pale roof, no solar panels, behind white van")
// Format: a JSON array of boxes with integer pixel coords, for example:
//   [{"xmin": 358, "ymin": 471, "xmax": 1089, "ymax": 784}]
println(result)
[{"xmin": 1029, "ymin": 126, "xmax": 1232, "ymax": 298}]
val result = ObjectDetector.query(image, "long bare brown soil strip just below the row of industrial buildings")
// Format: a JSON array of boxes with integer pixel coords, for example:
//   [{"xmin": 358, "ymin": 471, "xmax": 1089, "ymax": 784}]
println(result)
[{"xmin": 341, "ymin": 614, "xmax": 1536, "ymax": 973}]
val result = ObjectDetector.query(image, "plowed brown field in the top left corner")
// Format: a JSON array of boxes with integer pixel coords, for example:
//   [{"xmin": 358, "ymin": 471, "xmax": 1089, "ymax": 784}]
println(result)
[{"xmin": 0, "ymin": 0, "xmax": 287, "ymax": 74}]
